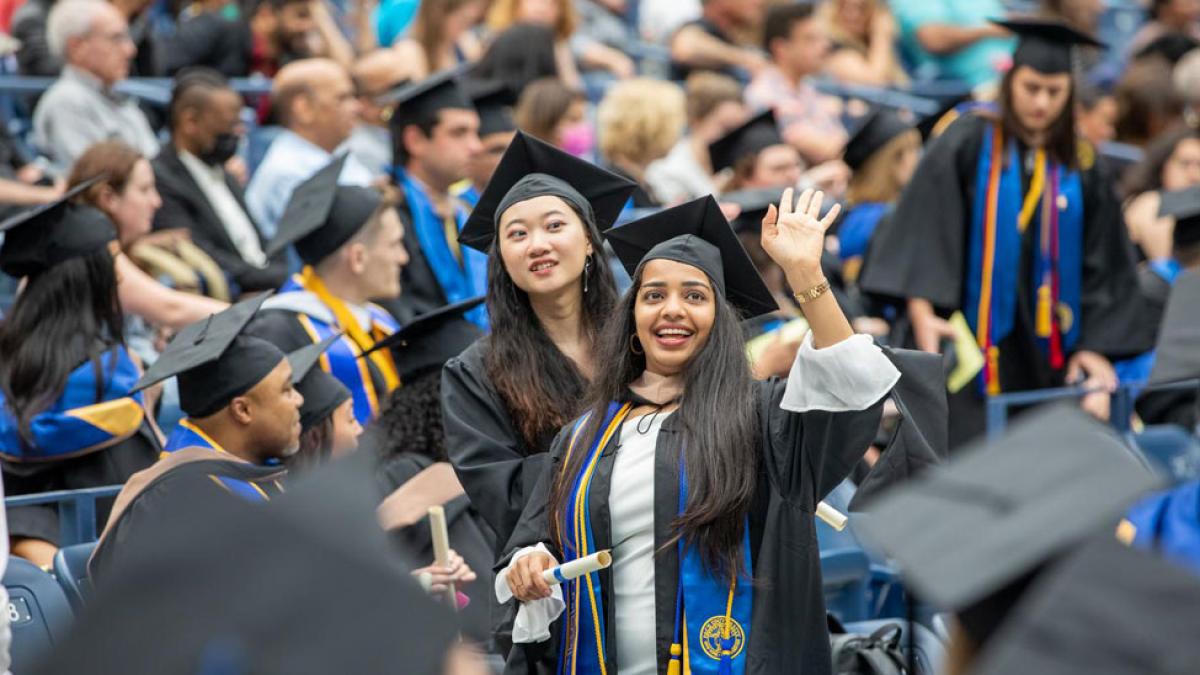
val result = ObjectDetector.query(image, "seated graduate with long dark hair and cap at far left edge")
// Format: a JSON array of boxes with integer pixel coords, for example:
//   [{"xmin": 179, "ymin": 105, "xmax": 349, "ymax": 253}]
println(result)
[{"xmin": 0, "ymin": 184, "xmax": 160, "ymax": 566}]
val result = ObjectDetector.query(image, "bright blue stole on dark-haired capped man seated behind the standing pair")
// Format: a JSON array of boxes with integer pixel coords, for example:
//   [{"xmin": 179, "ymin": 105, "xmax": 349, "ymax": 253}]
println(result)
[{"xmin": 392, "ymin": 167, "xmax": 487, "ymax": 330}]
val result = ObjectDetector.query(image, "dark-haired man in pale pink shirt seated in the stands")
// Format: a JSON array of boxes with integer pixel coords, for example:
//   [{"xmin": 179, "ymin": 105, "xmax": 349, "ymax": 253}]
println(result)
[{"xmin": 745, "ymin": 5, "xmax": 846, "ymax": 165}]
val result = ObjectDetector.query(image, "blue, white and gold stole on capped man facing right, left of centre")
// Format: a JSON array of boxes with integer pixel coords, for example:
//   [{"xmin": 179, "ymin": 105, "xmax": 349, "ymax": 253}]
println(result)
[{"xmin": 280, "ymin": 268, "xmax": 400, "ymax": 426}]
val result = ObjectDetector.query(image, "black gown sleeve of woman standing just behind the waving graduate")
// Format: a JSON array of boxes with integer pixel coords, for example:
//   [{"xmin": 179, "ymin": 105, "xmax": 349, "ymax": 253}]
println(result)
[{"xmin": 442, "ymin": 344, "xmax": 546, "ymax": 544}]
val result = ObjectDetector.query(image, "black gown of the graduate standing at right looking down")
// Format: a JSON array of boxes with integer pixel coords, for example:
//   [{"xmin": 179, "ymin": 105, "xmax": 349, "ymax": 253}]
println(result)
[{"xmin": 859, "ymin": 114, "xmax": 1153, "ymax": 446}]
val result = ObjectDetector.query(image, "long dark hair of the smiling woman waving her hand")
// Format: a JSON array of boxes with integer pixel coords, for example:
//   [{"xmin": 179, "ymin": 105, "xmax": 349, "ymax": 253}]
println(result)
[{"xmin": 550, "ymin": 270, "xmax": 758, "ymax": 579}]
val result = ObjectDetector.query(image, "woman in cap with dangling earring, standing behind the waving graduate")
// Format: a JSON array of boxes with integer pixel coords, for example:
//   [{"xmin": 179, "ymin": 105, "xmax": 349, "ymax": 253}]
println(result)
[{"xmin": 442, "ymin": 133, "xmax": 635, "ymax": 552}]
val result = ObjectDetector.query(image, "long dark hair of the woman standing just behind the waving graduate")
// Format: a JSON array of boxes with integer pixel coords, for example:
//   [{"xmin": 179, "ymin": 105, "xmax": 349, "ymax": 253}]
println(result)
[{"xmin": 484, "ymin": 199, "xmax": 617, "ymax": 454}]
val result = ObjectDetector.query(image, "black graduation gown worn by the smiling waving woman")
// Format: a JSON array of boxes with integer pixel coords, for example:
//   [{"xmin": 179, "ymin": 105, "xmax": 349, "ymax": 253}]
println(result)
[{"xmin": 498, "ymin": 378, "xmax": 882, "ymax": 675}]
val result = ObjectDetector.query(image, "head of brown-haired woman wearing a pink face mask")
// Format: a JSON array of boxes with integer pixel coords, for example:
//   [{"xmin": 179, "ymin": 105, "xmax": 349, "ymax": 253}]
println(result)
[{"xmin": 514, "ymin": 77, "xmax": 595, "ymax": 153}]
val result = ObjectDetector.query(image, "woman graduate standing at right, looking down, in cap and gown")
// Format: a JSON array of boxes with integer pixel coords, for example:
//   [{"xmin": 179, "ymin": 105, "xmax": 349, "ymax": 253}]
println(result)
[{"xmin": 859, "ymin": 19, "xmax": 1153, "ymax": 444}]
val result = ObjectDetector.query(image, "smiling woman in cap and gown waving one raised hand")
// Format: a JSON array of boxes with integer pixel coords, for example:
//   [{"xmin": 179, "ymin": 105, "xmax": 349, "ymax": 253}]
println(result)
[{"xmin": 497, "ymin": 190, "xmax": 899, "ymax": 675}]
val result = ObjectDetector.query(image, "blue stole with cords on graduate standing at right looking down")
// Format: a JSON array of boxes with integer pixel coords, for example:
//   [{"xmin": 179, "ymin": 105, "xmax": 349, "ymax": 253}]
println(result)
[{"xmin": 965, "ymin": 125, "xmax": 1084, "ymax": 395}]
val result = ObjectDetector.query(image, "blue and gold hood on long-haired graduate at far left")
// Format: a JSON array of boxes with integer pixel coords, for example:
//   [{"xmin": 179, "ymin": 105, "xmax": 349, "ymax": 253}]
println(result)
[{"xmin": 0, "ymin": 346, "xmax": 145, "ymax": 462}]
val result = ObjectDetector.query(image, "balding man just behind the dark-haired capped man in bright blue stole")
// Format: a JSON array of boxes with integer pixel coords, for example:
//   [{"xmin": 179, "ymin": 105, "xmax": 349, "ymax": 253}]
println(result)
[{"xmin": 346, "ymin": 49, "xmax": 419, "ymax": 177}]
